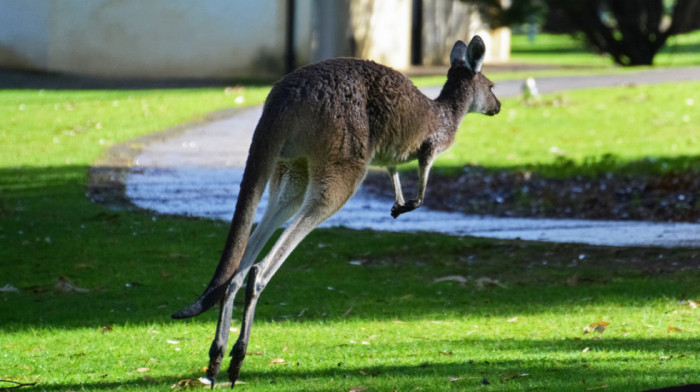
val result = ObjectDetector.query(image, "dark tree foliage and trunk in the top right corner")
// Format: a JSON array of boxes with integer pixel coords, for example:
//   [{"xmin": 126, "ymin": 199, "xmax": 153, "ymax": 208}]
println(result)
[{"xmin": 464, "ymin": 0, "xmax": 700, "ymax": 66}]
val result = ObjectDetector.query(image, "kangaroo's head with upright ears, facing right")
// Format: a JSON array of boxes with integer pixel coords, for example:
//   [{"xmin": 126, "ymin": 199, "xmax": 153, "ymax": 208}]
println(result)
[{"xmin": 450, "ymin": 35, "xmax": 501, "ymax": 116}]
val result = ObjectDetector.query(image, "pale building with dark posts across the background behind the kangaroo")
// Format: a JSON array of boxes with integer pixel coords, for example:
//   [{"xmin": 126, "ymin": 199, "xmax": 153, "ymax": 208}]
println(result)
[{"xmin": 0, "ymin": 0, "xmax": 510, "ymax": 79}]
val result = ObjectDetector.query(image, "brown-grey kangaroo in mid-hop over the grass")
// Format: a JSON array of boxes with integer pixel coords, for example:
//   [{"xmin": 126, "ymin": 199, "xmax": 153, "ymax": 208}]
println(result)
[{"xmin": 172, "ymin": 36, "xmax": 501, "ymax": 387}]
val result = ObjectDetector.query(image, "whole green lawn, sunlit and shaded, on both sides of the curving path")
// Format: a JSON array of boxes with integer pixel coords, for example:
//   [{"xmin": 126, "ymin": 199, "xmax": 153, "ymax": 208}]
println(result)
[{"xmin": 0, "ymin": 76, "xmax": 700, "ymax": 391}]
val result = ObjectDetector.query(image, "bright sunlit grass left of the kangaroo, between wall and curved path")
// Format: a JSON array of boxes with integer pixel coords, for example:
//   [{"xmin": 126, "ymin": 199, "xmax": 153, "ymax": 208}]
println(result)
[{"xmin": 0, "ymin": 87, "xmax": 269, "ymax": 167}]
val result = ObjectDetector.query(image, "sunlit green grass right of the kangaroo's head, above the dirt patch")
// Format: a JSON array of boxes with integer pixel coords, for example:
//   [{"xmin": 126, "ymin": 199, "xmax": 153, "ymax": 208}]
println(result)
[{"xmin": 436, "ymin": 82, "xmax": 700, "ymax": 176}]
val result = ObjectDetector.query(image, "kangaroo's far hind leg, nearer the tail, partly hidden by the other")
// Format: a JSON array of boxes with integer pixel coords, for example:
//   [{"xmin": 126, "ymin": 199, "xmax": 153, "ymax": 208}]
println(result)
[{"xmin": 207, "ymin": 161, "xmax": 308, "ymax": 385}]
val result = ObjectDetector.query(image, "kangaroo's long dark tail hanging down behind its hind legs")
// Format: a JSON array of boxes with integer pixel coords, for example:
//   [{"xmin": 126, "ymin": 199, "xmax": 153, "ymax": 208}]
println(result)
[{"xmin": 172, "ymin": 116, "xmax": 279, "ymax": 319}]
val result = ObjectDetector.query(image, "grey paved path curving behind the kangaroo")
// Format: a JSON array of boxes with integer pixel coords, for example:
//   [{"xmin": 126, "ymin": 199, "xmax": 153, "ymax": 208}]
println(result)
[{"xmin": 126, "ymin": 67, "xmax": 700, "ymax": 247}]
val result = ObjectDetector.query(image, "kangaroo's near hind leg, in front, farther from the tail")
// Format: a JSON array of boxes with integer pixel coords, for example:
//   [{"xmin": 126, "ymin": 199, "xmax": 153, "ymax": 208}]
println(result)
[{"xmin": 228, "ymin": 162, "xmax": 366, "ymax": 385}]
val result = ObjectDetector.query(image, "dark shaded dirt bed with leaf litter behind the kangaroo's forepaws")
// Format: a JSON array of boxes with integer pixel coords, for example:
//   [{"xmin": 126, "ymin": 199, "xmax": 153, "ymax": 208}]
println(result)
[{"xmin": 364, "ymin": 166, "xmax": 700, "ymax": 223}]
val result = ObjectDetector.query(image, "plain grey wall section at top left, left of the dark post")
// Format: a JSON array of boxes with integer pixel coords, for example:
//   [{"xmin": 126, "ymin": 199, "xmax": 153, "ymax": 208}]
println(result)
[{"xmin": 0, "ymin": 0, "xmax": 286, "ymax": 78}]
